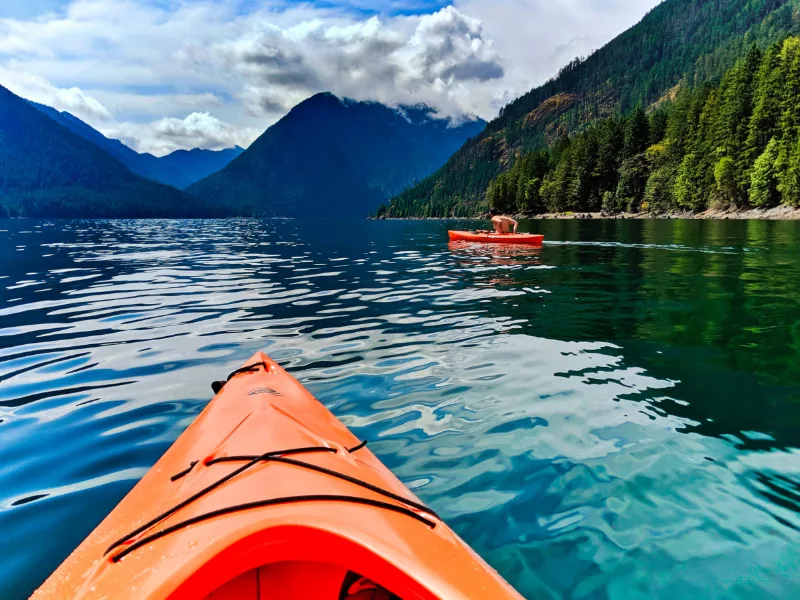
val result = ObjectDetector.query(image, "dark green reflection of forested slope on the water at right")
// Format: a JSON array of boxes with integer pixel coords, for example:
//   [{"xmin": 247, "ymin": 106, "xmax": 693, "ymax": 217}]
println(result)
[{"xmin": 448, "ymin": 220, "xmax": 800, "ymax": 450}]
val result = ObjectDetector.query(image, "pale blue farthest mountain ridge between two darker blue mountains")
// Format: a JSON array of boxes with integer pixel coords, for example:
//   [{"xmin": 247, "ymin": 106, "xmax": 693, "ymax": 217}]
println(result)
[{"xmin": 31, "ymin": 102, "xmax": 244, "ymax": 189}]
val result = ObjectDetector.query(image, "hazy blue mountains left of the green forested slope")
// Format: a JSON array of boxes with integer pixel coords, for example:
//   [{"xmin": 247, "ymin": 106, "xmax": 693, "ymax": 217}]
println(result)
[{"xmin": 0, "ymin": 88, "xmax": 486, "ymax": 217}]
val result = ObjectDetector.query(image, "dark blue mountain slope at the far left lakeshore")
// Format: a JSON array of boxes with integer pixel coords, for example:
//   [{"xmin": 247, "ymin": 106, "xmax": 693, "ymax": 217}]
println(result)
[{"xmin": 0, "ymin": 86, "xmax": 215, "ymax": 217}]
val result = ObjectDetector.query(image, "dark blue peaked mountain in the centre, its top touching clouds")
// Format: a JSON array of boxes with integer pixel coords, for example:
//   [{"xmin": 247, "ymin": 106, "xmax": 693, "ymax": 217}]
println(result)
[{"xmin": 188, "ymin": 93, "xmax": 486, "ymax": 216}]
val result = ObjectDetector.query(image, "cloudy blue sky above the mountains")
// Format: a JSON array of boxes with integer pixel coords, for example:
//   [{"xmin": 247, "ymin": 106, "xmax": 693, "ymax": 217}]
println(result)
[{"xmin": 0, "ymin": 0, "xmax": 658, "ymax": 154}]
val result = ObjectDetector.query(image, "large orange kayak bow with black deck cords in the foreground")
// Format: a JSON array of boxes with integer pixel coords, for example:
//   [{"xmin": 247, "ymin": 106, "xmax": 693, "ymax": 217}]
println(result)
[{"xmin": 33, "ymin": 353, "xmax": 521, "ymax": 600}]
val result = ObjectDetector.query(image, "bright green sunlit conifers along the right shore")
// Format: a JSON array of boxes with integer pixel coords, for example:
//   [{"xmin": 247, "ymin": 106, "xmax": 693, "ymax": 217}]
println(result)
[{"xmin": 378, "ymin": 37, "xmax": 800, "ymax": 216}]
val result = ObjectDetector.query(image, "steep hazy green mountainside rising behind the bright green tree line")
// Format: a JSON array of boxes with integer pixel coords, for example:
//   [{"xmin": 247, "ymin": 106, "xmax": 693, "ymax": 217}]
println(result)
[{"xmin": 383, "ymin": 0, "xmax": 800, "ymax": 216}]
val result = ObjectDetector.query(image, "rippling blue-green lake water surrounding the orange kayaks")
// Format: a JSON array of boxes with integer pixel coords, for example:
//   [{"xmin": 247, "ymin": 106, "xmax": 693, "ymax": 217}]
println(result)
[{"xmin": 0, "ymin": 221, "xmax": 800, "ymax": 600}]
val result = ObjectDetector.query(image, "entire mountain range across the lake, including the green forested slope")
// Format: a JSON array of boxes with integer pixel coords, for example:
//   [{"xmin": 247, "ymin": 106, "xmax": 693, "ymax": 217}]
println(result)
[{"xmin": 0, "ymin": 0, "xmax": 800, "ymax": 217}]
